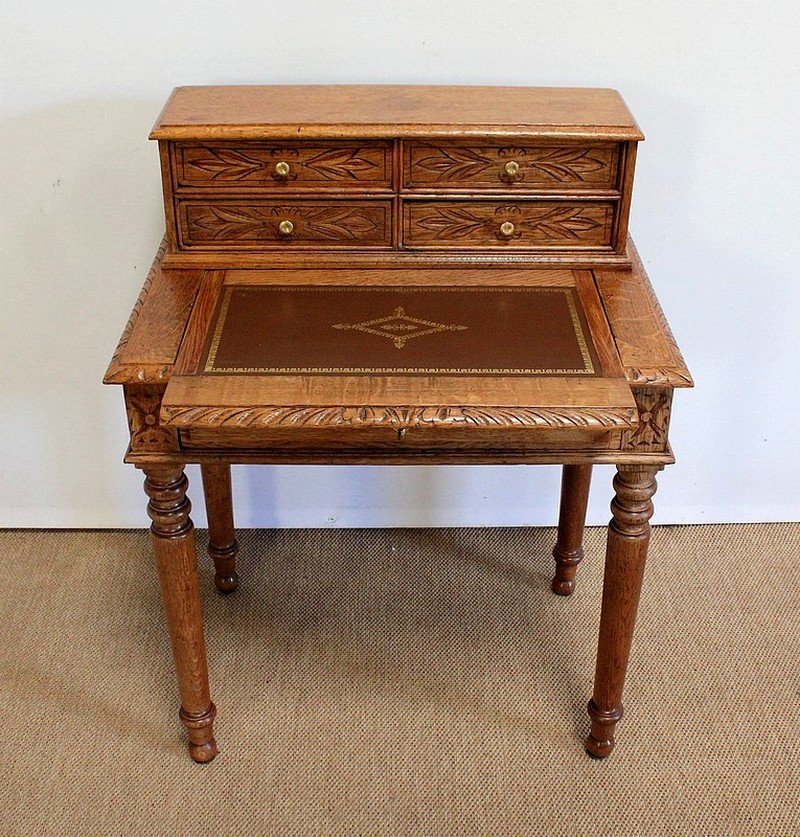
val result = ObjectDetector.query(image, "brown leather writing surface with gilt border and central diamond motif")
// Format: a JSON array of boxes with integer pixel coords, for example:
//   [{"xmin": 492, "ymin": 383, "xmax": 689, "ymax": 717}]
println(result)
[{"xmin": 198, "ymin": 285, "xmax": 600, "ymax": 376}]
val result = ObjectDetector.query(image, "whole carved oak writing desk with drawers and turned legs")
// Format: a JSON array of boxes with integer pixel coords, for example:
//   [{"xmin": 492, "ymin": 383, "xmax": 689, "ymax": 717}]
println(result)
[{"xmin": 105, "ymin": 86, "xmax": 692, "ymax": 762}]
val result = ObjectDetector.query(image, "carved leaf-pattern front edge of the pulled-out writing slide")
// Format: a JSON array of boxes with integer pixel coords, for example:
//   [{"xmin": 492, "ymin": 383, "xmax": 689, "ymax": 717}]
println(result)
[{"xmin": 161, "ymin": 405, "xmax": 637, "ymax": 430}]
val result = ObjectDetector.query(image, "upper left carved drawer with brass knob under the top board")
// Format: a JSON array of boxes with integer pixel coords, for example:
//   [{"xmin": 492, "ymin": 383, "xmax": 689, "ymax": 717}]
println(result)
[{"xmin": 174, "ymin": 142, "xmax": 392, "ymax": 192}]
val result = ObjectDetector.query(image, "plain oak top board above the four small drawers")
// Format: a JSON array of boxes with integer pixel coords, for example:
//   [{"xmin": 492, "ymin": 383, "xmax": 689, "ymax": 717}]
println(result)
[{"xmin": 150, "ymin": 85, "xmax": 644, "ymax": 140}]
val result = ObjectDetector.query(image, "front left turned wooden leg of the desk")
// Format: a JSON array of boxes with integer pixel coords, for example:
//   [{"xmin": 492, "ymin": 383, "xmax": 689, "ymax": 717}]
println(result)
[{"xmin": 144, "ymin": 466, "xmax": 217, "ymax": 762}]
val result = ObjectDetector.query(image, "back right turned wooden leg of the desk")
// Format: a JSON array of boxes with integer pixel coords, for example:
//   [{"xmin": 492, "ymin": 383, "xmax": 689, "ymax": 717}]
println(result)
[{"xmin": 551, "ymin": 465, "xmax": 592, "ymax": 596}]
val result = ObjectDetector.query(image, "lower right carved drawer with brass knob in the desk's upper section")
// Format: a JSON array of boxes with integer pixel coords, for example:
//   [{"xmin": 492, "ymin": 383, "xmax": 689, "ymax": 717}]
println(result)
[{"xmin": 403, "ymin": 200, "xmax": 616, "ymax": 249}]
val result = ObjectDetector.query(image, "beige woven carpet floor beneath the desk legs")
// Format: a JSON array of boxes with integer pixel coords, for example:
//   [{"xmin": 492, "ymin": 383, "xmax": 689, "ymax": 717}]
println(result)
[{"xmin": 0, "ymin": 524, "xmax": 800, "ymax": 835}]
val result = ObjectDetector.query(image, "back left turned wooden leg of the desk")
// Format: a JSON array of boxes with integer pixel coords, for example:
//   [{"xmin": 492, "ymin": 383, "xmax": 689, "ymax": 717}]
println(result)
[{"xmin": 200, "ymin": 462, "xmax": 239, "ymax": 593}]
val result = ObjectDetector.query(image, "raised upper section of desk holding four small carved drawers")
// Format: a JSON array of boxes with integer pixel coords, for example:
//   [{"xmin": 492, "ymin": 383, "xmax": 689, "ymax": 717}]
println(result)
[{"xmin": 151, "ymin": 85, "xmax": 643, "ymax": 268}]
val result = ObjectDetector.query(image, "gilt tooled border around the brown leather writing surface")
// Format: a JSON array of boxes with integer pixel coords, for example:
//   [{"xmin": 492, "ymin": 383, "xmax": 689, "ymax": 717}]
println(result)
[{"xmin": 203, "ymin": 285, "xmax": 595, "ymax": 375}]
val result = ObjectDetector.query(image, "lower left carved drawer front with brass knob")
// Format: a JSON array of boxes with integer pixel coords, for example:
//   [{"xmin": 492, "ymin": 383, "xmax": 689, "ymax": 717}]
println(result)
[{"xmin": 178, "ymin": 199, "xmax": 392, "ymax": 250}]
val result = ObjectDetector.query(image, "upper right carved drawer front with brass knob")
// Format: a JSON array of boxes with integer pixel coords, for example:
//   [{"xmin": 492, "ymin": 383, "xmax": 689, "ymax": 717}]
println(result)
[{"xmin": 403, "ymin": 143, "xmax": 619, "ymax": 191}]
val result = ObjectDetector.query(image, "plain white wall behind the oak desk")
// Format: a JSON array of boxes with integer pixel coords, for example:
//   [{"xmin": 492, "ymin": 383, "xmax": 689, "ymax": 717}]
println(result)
[{"xmin": 0, "ymin": 0, "xmax": 800, "ymax": 526}]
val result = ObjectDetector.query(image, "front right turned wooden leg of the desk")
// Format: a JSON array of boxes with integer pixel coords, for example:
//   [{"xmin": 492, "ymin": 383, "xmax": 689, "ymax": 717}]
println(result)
[{"xmin": 586, "ymin": 466, "xmax": 658, "ymax": 758}]
